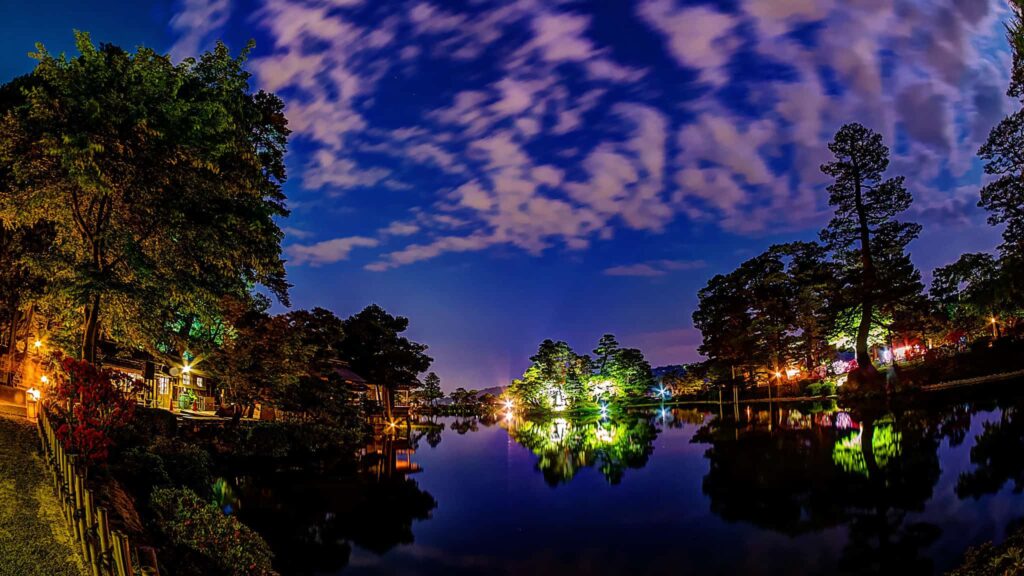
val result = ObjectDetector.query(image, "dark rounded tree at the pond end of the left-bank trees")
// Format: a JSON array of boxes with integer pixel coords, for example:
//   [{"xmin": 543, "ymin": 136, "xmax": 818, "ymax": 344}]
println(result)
[{"xmin": 338, "ymin": 304, "xmax": 433, "ymax": 417}]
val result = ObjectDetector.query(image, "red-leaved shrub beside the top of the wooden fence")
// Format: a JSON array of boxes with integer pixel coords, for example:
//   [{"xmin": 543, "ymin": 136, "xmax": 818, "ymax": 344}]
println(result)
[{"xmin": 49, "ymin": 358, "xmax": 140, "ymax": 462}]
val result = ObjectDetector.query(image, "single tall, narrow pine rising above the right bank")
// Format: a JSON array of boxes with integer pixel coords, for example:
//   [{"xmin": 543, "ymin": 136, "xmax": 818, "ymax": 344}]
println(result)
[{"xmin": 821, "ymin": 123, "xmax": 922, "ymax": 374}]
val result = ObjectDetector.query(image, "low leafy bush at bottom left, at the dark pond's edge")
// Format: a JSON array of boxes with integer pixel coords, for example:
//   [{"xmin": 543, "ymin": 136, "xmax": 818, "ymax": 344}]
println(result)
[{"xmin": 152, "ymin": 488, "xmax": 276, "ymax": 576}]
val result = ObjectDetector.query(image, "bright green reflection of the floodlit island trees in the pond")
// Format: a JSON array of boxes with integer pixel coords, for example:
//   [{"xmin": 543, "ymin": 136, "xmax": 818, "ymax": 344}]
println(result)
[{"xmin": 503, "ymin": 415, "xmax": 657, "ymax": 486}]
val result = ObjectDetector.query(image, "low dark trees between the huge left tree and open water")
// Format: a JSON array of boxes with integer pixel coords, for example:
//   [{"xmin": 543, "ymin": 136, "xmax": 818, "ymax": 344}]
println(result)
[{"xmin": 207, "ymin": 298, "xmax": 439, "ymax": 424}]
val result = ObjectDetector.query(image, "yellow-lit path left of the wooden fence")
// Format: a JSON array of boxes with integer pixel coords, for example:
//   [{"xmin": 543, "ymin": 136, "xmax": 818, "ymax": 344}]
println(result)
[{"xmin": 0, "ymin": 415, "xmax": 85, "ymax": 576}]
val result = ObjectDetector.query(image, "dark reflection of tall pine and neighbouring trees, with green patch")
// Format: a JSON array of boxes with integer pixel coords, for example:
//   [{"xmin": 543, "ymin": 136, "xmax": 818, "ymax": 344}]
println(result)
[{"xmin": 693, "ymin": 403, "xmax": 941, "ymax": 574}]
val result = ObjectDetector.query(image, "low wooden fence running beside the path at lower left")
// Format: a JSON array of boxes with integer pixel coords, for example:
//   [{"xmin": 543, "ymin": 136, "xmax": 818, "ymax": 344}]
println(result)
[{"xmin": 38, "ymin": 410, "xmax": 160, "ymax": 576}]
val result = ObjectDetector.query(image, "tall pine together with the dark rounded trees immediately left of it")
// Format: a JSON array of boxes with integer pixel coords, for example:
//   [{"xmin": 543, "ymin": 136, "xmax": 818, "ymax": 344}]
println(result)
[{"xmin": 693, "ymin": 124, "xmax": 929, "ymax": 389}]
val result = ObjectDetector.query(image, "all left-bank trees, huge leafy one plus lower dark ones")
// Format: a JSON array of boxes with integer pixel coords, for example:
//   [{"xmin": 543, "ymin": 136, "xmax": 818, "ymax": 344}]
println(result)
[{"xmin": 0, "ymin": 33, "xmax": 431, "ymax": 419}]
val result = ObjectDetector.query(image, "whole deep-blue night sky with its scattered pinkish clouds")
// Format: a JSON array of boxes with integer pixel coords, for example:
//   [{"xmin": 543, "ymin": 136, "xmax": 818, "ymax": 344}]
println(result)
[{"xmin": 0, "ymin": 0, "xmax": 1012, "ymax": 389}]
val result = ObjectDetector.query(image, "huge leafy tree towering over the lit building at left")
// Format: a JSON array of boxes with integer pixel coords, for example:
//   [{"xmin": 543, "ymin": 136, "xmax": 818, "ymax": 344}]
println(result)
[{"xmin": 0, "ymin": 33, "xmax": 289, "ymax": 362}]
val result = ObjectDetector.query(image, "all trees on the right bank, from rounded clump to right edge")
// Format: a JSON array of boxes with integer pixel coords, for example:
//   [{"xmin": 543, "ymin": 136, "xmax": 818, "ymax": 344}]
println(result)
[{"xmin": 693, "ymin": 2, "xmax": 1024, "ymax": 391}]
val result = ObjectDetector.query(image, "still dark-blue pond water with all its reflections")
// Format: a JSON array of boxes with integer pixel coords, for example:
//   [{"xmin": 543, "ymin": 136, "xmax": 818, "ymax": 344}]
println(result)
[{"xmin": 234, "ymin": 383, "xmax": 1024, "ymax": 576}]
